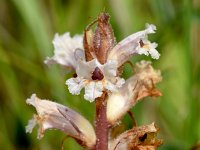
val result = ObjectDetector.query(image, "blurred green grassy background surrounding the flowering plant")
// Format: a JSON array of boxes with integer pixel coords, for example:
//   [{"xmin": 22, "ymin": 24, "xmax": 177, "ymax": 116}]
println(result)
[{"xmin": 0, "ymin": 0, "xmax": 200, "ymax": 150}]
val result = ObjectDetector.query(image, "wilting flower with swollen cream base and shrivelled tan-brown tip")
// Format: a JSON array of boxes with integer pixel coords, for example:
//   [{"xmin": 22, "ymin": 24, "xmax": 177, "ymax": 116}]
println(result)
[{"xmin": 107, "ymin": 61, "xmax": 162, "ymax": 124}]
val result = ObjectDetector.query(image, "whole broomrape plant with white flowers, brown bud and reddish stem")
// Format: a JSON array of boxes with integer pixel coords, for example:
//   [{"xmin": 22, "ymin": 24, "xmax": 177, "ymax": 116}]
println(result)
[{"xmin": 26, "ymin": 12, "xmax": 162, "ymax": 150}]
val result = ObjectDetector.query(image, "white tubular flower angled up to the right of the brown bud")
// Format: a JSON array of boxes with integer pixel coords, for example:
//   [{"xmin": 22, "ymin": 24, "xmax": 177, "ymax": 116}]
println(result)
[{"xmin": 108, "ymin": 24, "xmax": 160, "ymax": 66}]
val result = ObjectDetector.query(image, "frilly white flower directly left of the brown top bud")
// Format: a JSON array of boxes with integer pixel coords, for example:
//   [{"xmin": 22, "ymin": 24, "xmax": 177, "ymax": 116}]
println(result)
[{"xmin": 44, "ymin": 32, "xmax": 83, "ymax": 69}]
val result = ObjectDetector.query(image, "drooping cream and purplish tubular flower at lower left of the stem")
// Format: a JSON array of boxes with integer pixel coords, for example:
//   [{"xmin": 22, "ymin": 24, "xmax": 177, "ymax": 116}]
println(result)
[{"xmin": 26, "ymin": 94, "xmax": 96, "ymax": 149}]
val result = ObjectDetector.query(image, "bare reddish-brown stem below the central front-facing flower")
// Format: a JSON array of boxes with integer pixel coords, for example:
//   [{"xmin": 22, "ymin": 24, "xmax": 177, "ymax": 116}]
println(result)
[{"xmin": 95, "ymin": 93, "xmax": 108, "ymax": 150}]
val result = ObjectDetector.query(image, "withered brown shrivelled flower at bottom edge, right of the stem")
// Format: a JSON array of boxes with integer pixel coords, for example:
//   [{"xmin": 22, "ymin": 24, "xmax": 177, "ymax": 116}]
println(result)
[{"xmin": 109, "ymin": 123, "xmax": 163, "ymax": 150}]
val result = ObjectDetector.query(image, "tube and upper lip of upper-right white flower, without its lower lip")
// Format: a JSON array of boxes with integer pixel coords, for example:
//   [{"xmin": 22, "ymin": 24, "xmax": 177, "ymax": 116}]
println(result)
[{"xmin": 108, "ymin": 24, "xmax": 156, "ymax": 67}]
